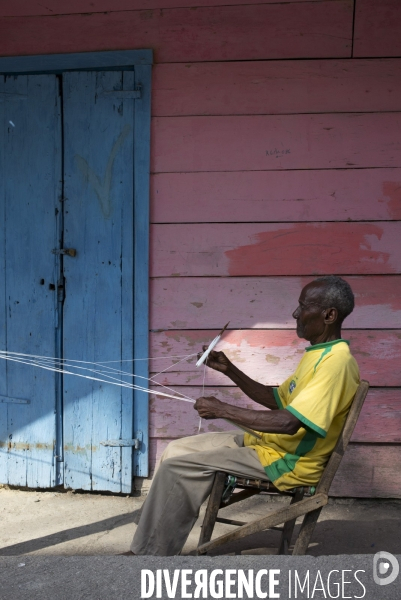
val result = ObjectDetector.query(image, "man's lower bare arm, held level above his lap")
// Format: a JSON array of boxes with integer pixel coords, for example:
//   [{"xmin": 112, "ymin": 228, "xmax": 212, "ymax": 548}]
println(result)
[{"xmin": 194, "ymin": 396, "xmax": 303, "ymax": 435}]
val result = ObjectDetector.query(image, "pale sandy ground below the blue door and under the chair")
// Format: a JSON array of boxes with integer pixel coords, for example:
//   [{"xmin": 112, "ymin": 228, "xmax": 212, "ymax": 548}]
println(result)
[{"xmin": 0, "ymin": 486, "xmax": 401, "ymax": 557}]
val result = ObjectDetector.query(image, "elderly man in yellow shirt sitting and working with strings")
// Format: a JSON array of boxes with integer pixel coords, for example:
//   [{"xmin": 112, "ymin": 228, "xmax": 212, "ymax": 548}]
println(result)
[{"xmin": 130, "ymin": 276, "xmax": 359, "ymax": 556}]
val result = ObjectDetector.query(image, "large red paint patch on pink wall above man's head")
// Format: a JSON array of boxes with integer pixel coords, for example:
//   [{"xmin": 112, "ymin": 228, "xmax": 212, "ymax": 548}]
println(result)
[{"xmin": 224, "ymin": 223, "xmax": 398, "ymax": 276}]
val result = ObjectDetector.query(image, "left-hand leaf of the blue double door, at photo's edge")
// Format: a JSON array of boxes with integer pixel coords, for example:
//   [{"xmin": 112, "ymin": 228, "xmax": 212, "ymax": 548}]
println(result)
[{"xmin": 0, "ymin": 75, "xmax": 62, "ymax": 487}]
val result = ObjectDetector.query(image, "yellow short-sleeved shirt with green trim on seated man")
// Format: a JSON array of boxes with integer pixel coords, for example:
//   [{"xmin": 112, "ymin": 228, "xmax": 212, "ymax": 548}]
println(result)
[{"xmin": 244, "ymin": 340, "xmax": 360, "ymax": 490}]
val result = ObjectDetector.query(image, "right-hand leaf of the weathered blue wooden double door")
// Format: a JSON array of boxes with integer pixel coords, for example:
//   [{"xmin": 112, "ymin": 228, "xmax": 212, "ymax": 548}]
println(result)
[{"xmin": 63, "ymin": 72, "xmax": 134, "ymax": 492}]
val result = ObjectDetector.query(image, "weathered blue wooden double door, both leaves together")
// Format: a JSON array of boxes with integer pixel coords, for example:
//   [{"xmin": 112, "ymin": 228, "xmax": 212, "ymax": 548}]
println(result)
[{"xmin": 0, "ymin": 65, "xmax": 148, "ymax": 493}]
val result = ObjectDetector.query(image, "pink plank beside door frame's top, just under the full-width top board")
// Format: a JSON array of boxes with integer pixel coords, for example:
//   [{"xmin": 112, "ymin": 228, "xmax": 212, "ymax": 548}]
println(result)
[{"xmin": 152, "ymin": 59, "xmax": 401, "ymax": 116}]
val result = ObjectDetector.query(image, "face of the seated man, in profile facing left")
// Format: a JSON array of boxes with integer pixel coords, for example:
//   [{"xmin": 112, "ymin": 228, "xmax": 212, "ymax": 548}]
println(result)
[{"xmin": 292, "ymin": 282, "xmax": 326, "ymax": 342}]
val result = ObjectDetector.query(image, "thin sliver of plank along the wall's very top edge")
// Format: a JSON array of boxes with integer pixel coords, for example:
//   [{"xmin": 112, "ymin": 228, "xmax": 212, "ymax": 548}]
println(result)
[{"xmin": 0, "ymin": 0, "xmax": 340, "ymax": 17}]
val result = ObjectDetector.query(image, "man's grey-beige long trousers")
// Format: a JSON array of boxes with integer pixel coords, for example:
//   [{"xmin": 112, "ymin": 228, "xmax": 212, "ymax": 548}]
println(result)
[{"xmin": 131, "ymin": 430, "xmax": 266, "ymax": 556}]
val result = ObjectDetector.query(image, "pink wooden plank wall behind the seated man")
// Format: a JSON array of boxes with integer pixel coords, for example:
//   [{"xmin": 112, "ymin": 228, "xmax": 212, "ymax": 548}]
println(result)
[{"xmin": 0, "ymin": 0, "xmax": 401, "ymax": 498}]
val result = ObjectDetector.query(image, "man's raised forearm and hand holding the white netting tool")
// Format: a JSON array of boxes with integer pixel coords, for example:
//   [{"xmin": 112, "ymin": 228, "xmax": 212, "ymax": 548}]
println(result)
[{"xmin": 204, "ymin": 346, "xmax": 278, "ymax": 410}]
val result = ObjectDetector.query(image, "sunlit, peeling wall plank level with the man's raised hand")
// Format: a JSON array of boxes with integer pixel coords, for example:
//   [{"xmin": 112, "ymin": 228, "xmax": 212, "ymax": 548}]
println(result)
[{"xmin": 150, "ymin": 329, "xmax": 401, "ymax": 387}]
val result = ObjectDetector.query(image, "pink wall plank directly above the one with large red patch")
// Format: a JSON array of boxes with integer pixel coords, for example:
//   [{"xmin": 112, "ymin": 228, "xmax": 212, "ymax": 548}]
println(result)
[{"xmin": 151, "ymin": 169, "xmax": 401, "ymax": 223}]
